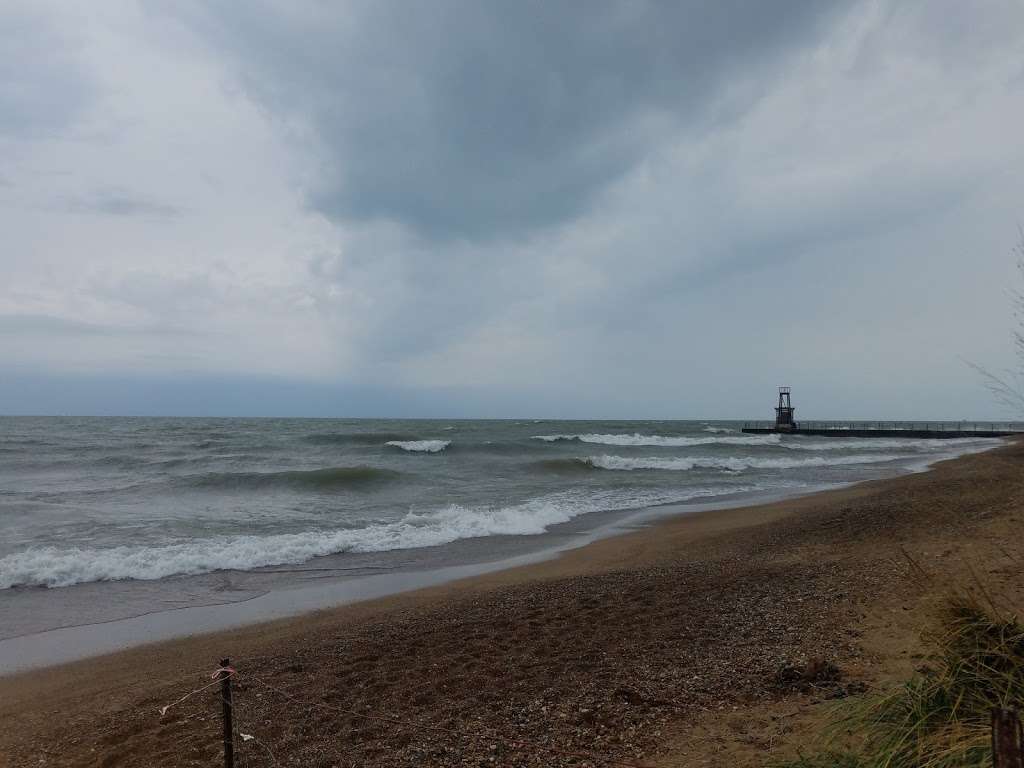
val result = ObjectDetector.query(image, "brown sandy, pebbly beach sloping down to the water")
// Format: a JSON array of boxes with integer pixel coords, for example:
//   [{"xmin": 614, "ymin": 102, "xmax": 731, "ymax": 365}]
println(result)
[{"xmin": 0, "ymin": 442, "xmax": 1024, "ymax": 766}]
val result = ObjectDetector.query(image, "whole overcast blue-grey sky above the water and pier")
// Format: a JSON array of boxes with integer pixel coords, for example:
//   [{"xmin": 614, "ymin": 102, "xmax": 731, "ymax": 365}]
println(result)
[{"xmin": 0, "ymin": 0, "xmax": 1024, "ymax": 419}]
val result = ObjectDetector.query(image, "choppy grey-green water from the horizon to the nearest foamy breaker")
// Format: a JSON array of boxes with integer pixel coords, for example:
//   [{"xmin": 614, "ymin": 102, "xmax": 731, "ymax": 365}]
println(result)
[{"xmin": 0, "ymin": 418, "xmax": 997, "ymax": 593}]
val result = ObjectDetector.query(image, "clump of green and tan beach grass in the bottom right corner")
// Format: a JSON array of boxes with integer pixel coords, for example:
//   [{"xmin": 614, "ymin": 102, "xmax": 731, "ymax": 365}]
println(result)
[{"xmin": 778, "ymin": 595, "xmax": 1024, "ymax": 768}]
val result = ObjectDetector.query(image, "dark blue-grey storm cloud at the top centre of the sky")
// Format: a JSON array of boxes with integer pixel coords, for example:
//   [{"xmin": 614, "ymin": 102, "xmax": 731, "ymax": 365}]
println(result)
[{"xmin": 172, "ymin": 0, "xmax": 840, "ymax": 240}]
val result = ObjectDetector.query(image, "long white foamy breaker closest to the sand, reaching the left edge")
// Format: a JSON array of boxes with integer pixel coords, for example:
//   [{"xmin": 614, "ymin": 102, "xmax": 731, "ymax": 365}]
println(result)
[{"xmin": 0, "ymin": 486, "xmax": 754, "ymax": 589}]
